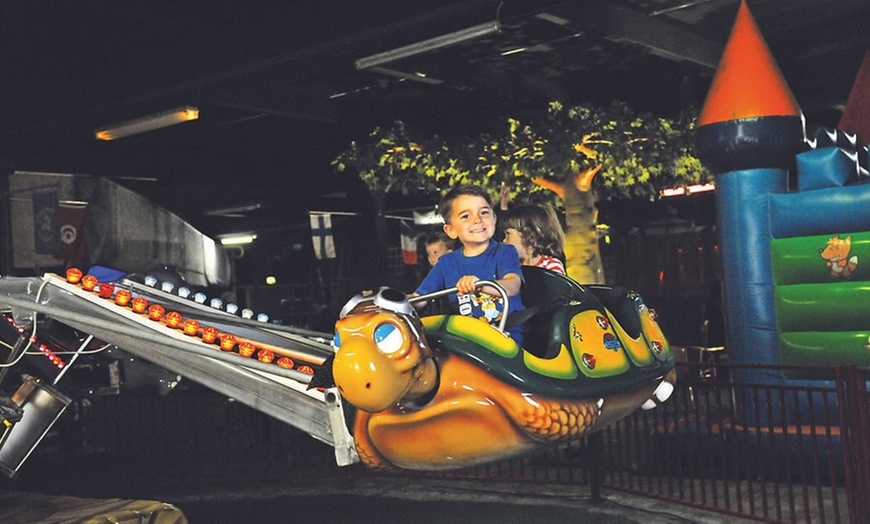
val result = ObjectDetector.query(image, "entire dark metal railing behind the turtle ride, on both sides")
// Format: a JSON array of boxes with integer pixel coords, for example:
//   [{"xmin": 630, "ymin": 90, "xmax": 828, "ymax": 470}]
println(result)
[{"xmin": 8, "ymin": 362, "xmax": 870, "ymax": 524}]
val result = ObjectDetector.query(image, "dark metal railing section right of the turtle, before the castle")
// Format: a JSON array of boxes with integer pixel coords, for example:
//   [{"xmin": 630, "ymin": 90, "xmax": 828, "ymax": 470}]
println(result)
[{"xmin": 376, "ymin": 361, "xmax": 870, "ymax": 523}]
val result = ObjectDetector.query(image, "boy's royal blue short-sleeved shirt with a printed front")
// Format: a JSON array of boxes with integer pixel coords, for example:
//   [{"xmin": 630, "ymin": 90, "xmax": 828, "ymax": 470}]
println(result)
[{"xmin": 415, "ymin": 241, "xmax": 525, "ymax": 346}]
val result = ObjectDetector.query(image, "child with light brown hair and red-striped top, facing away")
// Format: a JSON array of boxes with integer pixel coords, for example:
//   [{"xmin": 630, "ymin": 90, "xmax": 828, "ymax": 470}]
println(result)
[{"xmin": 503, "ymin": 205, "xmax": 565, "ymax": 275}]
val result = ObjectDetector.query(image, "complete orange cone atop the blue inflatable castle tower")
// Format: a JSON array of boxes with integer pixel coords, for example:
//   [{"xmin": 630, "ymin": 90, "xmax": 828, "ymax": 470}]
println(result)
[{"xmin": 698, "ymin": 0, "xmax": 801, "ymax": 126}]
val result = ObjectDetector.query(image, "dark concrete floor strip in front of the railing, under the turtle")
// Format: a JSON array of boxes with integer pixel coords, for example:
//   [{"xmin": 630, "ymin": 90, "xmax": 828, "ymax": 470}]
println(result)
[{"xmin": 145, "ymin": 477, "xmax": 752, "ymax": 524}]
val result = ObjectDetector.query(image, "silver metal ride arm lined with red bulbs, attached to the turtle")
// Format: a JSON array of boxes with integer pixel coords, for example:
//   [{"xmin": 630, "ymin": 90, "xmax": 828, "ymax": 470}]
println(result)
[{"xmin": 0, "ymin": 273, "xmax": 359, "ymax": 466}]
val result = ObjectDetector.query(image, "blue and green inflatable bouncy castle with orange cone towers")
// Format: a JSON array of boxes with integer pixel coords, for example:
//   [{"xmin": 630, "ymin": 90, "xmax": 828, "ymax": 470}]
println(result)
[{"xmin": 697, "ymin": 0, "xmax": 870, "ymax": 402}]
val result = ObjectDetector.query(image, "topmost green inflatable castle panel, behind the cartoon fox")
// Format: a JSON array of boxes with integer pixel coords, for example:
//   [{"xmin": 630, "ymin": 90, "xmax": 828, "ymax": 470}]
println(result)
[{"xmin": 770, "ymin": 231, "xmax": 870, "ymax": 285}]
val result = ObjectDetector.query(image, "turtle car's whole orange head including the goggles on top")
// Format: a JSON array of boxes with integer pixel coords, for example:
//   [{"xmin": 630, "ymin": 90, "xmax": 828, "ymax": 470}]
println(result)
[{"xmin": 332, "ymin": 288, "xmax": 437, "ymax": 413}]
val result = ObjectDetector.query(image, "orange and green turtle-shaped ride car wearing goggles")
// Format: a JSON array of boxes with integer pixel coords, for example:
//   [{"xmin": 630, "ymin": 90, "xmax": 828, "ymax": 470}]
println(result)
[{"xmin": 332, "ymin": 268, "xmax": 676, "ymax": 470}]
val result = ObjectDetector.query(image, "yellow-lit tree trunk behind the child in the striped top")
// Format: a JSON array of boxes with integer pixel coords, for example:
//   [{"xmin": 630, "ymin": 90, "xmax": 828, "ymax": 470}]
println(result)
[{"xmin": 562, "ymin": 178, "xmax": 604, "ymax": 284}]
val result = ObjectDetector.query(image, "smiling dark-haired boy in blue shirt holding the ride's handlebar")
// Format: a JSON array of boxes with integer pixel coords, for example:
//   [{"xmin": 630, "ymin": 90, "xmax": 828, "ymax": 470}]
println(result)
[{"xmin": 415, "ymin": 186, "xmax": 525, "ymax": 345}]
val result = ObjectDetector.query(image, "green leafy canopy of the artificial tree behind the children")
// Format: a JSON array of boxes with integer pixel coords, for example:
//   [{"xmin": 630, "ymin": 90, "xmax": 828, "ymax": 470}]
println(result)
[{"xmin": 333, "ymin": 102, "xmax": 712, "ymax": 205}]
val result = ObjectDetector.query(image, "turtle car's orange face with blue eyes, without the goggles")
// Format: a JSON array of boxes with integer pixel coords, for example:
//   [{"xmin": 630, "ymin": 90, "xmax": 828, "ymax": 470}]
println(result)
[{"xmin": 332, "ymin": 312, "xmax": 431, "ymax": 413}]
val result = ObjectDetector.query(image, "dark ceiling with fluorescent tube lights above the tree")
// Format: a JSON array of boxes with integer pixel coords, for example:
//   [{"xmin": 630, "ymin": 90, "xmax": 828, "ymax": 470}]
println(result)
[{"xmin": 0, "ymin": 0, "xmax": 870, "ymax": 237}]
